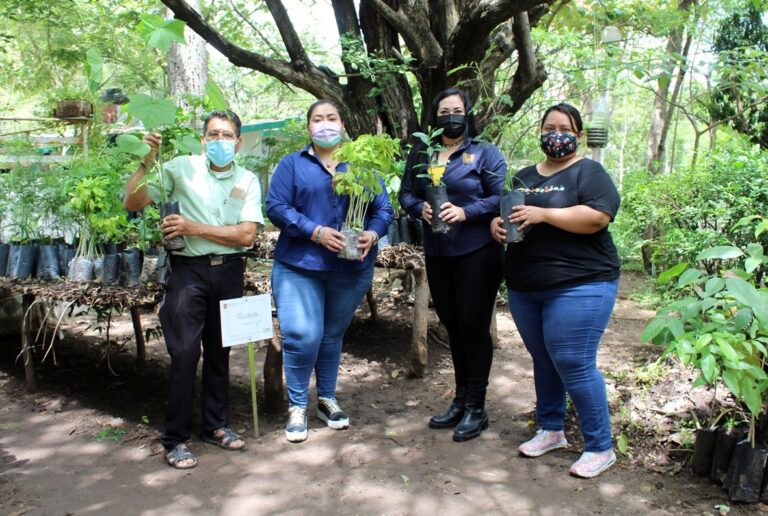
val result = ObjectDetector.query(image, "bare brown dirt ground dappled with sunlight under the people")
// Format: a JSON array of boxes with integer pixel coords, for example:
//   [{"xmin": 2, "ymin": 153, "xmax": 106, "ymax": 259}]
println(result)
[{"xmin": 0, "ymin": 273, "xmax": 762, "ymax": 515}]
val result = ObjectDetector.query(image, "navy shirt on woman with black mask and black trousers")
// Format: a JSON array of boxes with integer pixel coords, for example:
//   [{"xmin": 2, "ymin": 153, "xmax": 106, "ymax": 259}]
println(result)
[{"xmin": 399, "ymin": 139, "xmax": 507, "ymax": 256}]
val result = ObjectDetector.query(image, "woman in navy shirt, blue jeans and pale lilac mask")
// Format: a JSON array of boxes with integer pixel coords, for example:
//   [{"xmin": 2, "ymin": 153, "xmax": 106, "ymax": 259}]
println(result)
[{"xmin": 266, "ymin": 100, "xmax": 392, "ymax": 442}]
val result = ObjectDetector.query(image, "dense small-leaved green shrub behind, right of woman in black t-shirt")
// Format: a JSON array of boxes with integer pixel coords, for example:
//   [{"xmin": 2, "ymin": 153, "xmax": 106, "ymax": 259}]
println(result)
[{"xmin": 612, "ymin": 145, "xmax": 768, "ymax": 272}]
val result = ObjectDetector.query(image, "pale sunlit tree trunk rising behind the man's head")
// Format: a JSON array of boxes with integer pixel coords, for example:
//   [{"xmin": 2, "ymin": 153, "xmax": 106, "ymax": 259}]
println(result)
[{"xmin": 166, "ymin": 0, "xmax": 208, "ymax": 126}]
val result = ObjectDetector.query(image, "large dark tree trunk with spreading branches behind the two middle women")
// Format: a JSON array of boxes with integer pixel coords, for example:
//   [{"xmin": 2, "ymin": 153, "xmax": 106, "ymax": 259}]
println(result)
[{"xmin": 162, "ymin": 0, "xmax": 554, "ymax": 139}]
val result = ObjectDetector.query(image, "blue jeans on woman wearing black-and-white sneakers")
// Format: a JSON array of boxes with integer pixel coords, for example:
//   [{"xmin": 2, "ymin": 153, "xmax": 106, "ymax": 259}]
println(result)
[{"xmin": 272, "ymin": 260, "xmax": 373, "ymax": 407}]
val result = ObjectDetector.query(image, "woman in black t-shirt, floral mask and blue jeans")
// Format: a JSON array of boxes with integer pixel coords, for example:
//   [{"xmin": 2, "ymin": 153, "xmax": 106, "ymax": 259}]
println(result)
[{"xmin": 491, "ymin": 104, "xmax": 619, "ymax": 478}]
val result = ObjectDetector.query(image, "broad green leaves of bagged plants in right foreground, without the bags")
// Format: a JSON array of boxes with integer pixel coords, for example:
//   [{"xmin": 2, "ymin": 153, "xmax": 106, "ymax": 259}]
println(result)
[{"xmin": 642, "ymin": 217, "xmax": 768, "ymax": 432}]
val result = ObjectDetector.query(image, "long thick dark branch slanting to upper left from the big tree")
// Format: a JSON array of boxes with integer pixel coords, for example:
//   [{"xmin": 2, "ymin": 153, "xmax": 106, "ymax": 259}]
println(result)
[{"xmin": 162, "ymin": 0, "xmax": 343, "ymax": 103}]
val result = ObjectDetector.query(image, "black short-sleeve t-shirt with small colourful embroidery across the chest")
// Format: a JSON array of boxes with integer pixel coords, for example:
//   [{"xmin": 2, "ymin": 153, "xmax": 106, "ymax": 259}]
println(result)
[{"xmin": 505, "ymin": 159, "xmax": 620, "ymax": 292}]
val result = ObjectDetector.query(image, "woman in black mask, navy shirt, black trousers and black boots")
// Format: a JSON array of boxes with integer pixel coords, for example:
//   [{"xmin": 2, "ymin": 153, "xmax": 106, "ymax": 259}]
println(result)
[{"xmin": 400, "ymin": 88, "xmax": 507, "ymax": 442}]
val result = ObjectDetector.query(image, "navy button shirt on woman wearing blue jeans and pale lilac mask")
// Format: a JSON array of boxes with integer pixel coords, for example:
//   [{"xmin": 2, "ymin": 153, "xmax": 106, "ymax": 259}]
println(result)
[{"xmin": 266, "ymin": 145, "xmax": 393, "ymax": 271}]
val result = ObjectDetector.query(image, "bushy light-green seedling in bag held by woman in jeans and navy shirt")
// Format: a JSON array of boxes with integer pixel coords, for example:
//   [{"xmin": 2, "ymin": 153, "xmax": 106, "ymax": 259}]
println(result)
[{"xmin": 333, "ymin": 134, "xmax": 399, "ymax": 260}]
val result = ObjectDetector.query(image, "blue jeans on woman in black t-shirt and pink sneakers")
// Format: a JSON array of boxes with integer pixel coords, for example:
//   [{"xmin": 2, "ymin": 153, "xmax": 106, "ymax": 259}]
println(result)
[{"xmin": 509, "ymin": 280, "xmax": 619, "ymax": 452}]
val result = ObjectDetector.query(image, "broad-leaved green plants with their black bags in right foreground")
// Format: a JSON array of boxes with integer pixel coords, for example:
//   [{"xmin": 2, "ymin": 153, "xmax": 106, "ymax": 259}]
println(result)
[{"xmin": 642, "ymin": 215, "xmax": 768, "ymax": 503}]
